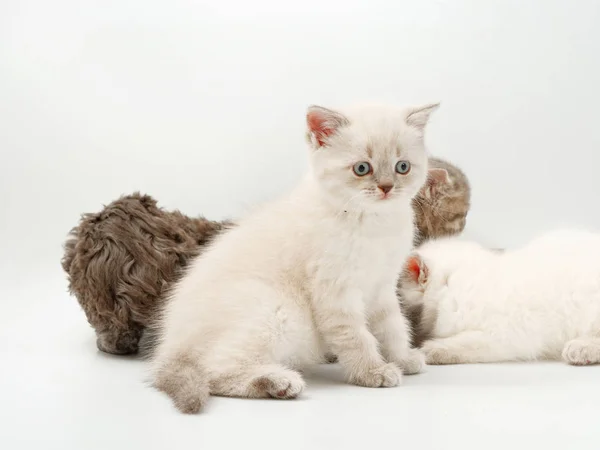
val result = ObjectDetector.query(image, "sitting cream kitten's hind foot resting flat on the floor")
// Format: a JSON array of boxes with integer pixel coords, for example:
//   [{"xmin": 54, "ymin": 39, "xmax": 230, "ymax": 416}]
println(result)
[{"xmin": 210, "ymin": 364, "xmax": 306, "ymax": 399}]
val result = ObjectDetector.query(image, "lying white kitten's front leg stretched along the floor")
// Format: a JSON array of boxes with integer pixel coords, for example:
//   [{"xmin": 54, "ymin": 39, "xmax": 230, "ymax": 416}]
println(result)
[{"xmin": 421, "ymin": 331, "xmax": 506, "ymax": 365}]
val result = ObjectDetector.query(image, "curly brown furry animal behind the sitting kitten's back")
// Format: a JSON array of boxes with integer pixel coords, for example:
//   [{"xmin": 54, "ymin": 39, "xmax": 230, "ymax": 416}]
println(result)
[{"xmin": 61, "ymin": 193, "xmax": 232, "ymax": 354}]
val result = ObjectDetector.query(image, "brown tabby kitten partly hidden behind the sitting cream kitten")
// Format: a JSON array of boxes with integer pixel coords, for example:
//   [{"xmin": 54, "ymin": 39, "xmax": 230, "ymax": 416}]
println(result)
[{"xmin": 413, "ymin": 158, "xmax": 471, "ymax": 246}]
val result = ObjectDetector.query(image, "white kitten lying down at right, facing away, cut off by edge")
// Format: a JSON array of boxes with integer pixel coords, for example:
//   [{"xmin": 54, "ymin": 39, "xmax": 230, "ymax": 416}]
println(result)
[{"xmin": 401, "ymin": 231, "xmax": 600, "ymax": 365}]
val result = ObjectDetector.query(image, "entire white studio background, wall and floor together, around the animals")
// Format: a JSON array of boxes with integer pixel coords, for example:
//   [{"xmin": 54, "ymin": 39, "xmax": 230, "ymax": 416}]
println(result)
[{"xmin": 0, "ymin": 0, "xmax": 600, "ymax": 450}]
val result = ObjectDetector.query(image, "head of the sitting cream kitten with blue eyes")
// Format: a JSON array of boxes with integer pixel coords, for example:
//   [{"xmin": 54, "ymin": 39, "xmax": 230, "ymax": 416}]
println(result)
[{"xmin": 306, "ymin": 104, "xmax": 438, "ymax": 210}]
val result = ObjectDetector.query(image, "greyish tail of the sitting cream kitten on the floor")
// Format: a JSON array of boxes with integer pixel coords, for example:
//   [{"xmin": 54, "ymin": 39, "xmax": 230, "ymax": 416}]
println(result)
[{"xmin": 154, "ymin": 352, "xmax": 210, "ymax": 414}]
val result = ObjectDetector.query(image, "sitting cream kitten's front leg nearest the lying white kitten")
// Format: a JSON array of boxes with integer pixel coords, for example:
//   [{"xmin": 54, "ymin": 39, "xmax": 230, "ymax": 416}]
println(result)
[{"xmin": 369, "ymin": 288, "xmax": 425, "ymax": 375}]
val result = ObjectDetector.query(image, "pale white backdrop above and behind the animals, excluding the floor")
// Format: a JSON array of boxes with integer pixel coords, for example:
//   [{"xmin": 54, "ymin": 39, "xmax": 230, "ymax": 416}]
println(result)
[{"xmin": 0, "ymin": 0, "xmax": 600, "ymax": 286}]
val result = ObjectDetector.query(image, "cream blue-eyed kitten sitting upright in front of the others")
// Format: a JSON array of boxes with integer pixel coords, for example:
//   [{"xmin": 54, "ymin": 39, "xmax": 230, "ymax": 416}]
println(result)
[{"xmin": 152, "ymin": 105, "xmax": 438, "ymax": 413}]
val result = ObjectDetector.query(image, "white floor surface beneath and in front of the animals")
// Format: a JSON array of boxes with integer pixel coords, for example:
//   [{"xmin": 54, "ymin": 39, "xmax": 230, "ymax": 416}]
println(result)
[{"xmin": 0, "ymin": 277, "xmax": 600, "ymax": 450}]
